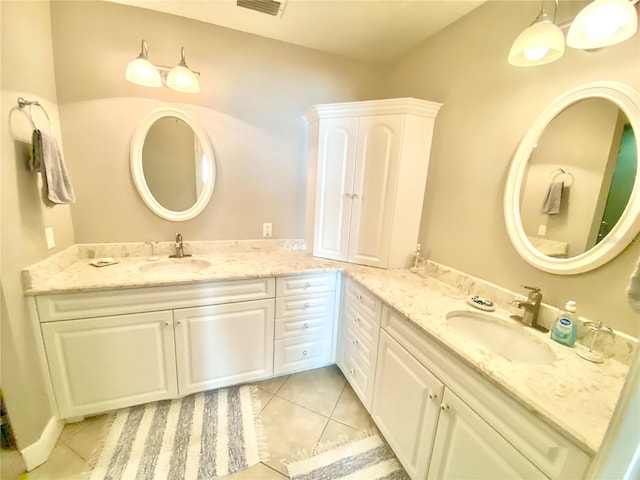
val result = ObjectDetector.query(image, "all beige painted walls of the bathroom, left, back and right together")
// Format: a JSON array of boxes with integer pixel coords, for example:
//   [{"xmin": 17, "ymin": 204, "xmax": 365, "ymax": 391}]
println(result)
[{"xmin": 0, "ymin": 1, "xmax": 640, "ymax": 454}]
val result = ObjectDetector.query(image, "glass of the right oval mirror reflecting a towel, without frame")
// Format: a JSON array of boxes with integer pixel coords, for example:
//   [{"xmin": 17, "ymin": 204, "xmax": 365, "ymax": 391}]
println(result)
[{"xmin": 520, "ymin": 98, "xmax": 637, "ymax": 258}]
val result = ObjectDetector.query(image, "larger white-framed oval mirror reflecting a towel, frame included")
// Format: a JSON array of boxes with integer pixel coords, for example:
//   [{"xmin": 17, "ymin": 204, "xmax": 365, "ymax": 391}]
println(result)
[{"xmin": 504, "ymin": 82, "xmax": 640, "ymax": 274}]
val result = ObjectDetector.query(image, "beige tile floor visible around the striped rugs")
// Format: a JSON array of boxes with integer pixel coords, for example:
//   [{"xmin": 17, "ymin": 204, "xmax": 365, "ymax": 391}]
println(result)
[{"xmin": 0, "ymin": 366, "xmax": 375, "ymax": 480}]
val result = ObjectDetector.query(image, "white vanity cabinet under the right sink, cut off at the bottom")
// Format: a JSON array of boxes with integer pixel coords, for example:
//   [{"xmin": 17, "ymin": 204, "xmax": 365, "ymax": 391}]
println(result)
[{"xmin": 373, "ymin": 306, "xmax": 590, "ymax": 480}]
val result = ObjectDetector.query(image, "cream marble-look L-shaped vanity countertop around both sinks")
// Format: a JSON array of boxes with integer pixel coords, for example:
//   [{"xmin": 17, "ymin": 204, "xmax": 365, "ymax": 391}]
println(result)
[{"xmin": 25, "ymin": 251, "xmax": 628, "ymax": 455}]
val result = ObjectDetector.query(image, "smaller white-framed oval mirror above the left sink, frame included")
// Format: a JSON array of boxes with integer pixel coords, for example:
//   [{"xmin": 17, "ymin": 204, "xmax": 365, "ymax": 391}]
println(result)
[{"xmin": 131, "ymin": 107, "xmax": 216, "ymax": 221}]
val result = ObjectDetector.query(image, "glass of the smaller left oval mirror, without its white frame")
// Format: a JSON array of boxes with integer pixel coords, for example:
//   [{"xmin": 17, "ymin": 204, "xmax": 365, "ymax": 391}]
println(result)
[{"xmin": 142, "ymin": 116, "xmax": 208, "ymax": 212}]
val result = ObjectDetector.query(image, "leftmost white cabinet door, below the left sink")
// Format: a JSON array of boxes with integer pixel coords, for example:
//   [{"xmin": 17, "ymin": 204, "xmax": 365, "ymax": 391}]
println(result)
[{"xmin": 42, "ymin": 312, "xmax": 177, "ymax": 418}]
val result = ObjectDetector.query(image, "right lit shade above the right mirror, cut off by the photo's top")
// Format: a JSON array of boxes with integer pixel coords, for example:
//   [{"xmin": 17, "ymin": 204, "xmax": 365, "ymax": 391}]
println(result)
[{"xmin": 567, "ymin": 0, "xmax": 638, "ymax": 50}]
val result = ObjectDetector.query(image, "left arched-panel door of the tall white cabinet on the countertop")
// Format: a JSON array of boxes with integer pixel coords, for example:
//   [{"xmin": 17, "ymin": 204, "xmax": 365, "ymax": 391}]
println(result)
[{"xmin": 313, "ymin": 118, "xmax": 358, "ymax": 261}]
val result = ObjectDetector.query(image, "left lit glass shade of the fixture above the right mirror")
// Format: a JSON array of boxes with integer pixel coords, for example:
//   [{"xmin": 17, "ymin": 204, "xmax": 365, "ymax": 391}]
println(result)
[{"xmin": 509, "ymin": 21, "xmax": 564, "ymax": 67}]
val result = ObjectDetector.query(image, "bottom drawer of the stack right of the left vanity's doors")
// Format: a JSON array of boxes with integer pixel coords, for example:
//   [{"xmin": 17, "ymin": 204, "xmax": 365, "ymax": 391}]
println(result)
[{"xmin": 273, "ymin": 331, "xmax": 332, "ymax": 375}]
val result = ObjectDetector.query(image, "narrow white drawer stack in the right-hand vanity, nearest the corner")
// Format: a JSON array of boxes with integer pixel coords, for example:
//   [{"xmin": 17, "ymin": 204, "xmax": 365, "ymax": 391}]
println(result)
[{"xmin": 337, "ymin": 279, "xmax": 382, "ymax": 412}]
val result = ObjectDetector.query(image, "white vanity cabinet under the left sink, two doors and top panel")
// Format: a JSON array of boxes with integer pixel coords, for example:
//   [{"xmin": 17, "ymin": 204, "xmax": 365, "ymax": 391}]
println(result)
[{"xmin": 35, "ymin": 278, "xmax": 275, "ymax": 418}]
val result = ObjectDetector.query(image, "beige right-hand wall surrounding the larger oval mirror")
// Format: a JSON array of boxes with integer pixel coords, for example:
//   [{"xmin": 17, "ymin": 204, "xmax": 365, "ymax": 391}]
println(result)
[{"xmin": 386, "ymin": 1, "xmax": 640, "ymax": 336}]
